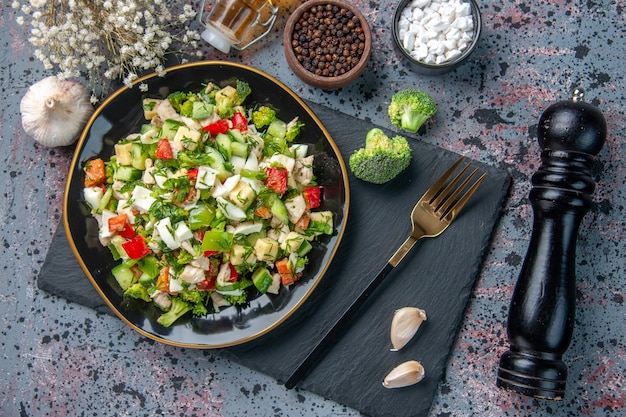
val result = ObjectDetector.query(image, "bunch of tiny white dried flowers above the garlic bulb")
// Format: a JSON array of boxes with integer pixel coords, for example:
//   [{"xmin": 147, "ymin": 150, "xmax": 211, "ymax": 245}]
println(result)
[{"xmin": 11, "ymin": 0, "xmax": 200, "ymax": 94}]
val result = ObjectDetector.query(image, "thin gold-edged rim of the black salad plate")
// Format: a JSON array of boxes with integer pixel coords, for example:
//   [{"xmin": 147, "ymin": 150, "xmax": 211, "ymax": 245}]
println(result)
[{"xmin": 63, "ymin": 60, "xmax": 350, "ymax": 349}]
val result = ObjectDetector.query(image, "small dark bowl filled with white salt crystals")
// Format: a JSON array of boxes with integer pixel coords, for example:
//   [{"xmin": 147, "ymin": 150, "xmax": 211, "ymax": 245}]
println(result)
[{"xmin": 393, "ymin": 0, "xmax": 482, "ymax": 75}]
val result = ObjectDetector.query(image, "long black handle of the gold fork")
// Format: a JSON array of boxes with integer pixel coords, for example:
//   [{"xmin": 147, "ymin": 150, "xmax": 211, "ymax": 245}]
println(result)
[{"xmin": 285, "ymin": 262, "xmax": 392, "ymax": 389}]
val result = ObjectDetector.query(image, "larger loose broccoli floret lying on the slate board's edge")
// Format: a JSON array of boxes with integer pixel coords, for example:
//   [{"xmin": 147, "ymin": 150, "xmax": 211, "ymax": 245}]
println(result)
[{"xmin": 348, "ymin": 128, "xmax": 411, "ymax": 184}]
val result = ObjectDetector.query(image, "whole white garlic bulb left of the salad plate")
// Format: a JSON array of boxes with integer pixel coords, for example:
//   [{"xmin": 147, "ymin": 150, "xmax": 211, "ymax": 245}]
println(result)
[{"xmin": 20, "ymin": 76, "xmax": 93, "ymax": 146}]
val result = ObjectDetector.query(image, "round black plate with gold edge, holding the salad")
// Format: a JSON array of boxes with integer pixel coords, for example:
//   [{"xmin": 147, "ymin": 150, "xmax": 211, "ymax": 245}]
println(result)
[{"xmin": 63, "ymin": 61, "xmax": 349, "ymax": 348}]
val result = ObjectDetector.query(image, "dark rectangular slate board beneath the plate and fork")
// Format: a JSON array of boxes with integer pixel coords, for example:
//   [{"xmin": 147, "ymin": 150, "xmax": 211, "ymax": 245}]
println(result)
[{"xmin": 38, "ymin": 103, "xmax": 510, "ymax": 417}]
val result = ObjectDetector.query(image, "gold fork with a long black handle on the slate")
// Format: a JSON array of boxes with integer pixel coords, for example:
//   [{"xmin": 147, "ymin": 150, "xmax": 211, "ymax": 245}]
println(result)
[{"xmin": 285, "ymin": 157, "xmax": 487, "ymax": 389}]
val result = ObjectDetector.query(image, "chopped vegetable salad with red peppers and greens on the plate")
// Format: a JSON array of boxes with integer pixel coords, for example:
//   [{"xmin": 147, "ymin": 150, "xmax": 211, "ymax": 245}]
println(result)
[{"xmin": 83, "ymin": 81, "xmax": 334, "ymax": 327}]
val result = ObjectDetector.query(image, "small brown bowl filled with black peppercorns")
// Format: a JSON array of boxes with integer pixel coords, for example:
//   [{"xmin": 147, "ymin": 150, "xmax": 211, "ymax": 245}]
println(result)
[{"xmin": 283, "ymin": 0, "xmax": 372, "ymax": 90}]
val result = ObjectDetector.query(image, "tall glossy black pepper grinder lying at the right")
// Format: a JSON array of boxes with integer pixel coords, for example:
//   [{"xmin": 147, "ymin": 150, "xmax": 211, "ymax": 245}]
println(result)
[{"xmin": 497, "ymin": 89, "xmax": 606, "ymax": 400}]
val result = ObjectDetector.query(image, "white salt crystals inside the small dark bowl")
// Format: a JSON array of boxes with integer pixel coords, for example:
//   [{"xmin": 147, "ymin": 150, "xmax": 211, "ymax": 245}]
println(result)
[{"xmin": 398, "ymin": 0, "xmax": 474, "ymax": 64}]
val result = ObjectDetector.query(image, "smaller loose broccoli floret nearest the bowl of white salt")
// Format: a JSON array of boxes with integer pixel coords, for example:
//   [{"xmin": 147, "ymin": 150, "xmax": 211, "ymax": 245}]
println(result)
[{"xmin": 387, "ymin": 88, "xmax": 437, "ymax": 133}]
